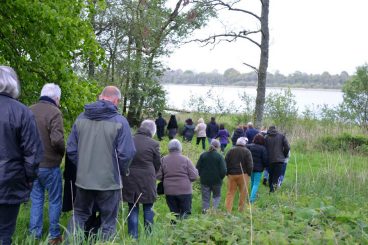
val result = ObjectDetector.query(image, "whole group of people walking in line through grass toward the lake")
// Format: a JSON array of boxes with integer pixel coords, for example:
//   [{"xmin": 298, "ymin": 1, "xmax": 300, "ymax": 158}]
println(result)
[{"xmin": 0, "ymin": 66, "xmax": 290, "ymax": 245}]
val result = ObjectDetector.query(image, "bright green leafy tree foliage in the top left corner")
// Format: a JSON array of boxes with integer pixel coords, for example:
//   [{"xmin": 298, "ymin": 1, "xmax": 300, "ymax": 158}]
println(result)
[{"xmin": 0, "ymin": 0, "xmax": 102, "ymax": 128}]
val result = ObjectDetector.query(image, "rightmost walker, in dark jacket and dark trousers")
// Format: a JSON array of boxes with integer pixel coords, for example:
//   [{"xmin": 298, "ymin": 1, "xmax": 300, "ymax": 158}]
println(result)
[{"xmin": 265, "ymin": 126, "xmax": 290, "ymax": 192}]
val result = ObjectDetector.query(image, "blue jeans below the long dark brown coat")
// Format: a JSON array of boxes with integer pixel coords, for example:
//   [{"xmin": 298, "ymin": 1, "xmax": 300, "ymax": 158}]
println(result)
[{"xmin": 128, "ymin": 203, "xmax": 155, "ymax": 239}]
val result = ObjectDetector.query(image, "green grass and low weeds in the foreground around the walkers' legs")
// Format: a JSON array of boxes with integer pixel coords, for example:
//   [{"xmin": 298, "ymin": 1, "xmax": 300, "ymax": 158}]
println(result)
[{"xmin": 13, "ymin": 129, "xmax": 368, "ymax": 244}]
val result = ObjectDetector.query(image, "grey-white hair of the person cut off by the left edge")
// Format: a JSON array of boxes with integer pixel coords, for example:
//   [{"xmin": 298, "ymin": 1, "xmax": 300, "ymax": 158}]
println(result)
[{"xmin": 0, "ymin": 66, "xmax": 20, "ymax": 99}]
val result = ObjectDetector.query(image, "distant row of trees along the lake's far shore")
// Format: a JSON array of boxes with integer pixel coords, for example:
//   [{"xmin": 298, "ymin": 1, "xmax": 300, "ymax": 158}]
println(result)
[{"xmin": 160, "ymin": 68, "xmax": 350, "ymax": 89}]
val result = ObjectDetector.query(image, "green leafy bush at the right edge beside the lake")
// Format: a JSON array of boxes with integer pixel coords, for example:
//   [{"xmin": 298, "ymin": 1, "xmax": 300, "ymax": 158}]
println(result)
[{"xmin": 343, "ymin": 64, "xmax": 368, "ymax": 129}]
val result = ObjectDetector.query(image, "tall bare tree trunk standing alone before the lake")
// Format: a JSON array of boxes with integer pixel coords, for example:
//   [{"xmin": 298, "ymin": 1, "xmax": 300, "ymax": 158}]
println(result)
[{"xmin": 254, "ymin": 0, "xmax": 270, "ymax": 128}]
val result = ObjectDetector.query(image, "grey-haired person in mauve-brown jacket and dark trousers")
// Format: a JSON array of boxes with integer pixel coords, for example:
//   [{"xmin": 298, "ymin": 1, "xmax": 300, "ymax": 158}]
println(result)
[{"xmin": 157, "ymin": 139, "xmax": 199, "ymax": 218}]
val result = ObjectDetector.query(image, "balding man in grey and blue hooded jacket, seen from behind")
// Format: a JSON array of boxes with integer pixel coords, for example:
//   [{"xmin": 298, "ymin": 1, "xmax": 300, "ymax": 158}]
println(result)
[{"xmin": 67, "ymin": 86, "xmax": 135, "ymax": 240}]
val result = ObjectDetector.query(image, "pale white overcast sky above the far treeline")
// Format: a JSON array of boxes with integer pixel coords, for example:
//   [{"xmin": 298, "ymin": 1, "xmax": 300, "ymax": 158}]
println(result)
[{"xmin": 164, "ymin": 0, "xmax": 368, "ymax": 75}]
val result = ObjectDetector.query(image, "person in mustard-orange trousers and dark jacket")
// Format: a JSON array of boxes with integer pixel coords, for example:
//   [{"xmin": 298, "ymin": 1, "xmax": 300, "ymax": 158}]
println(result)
[{"xmin": 225, "ymin": 137, "xmax": 253, "ymax": 212}]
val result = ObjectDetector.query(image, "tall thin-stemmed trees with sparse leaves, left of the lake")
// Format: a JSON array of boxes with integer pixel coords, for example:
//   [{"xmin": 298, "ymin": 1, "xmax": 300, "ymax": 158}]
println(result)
[{"xmin": 84, "ymin": 0, "xmax": 211, "ymax": 125}]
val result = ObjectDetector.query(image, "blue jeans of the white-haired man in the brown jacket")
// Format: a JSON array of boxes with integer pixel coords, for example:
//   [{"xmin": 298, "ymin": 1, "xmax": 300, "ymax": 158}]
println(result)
[{"xmin": 29, "ymin": 167, "xmax": 62, "ymax": 239}]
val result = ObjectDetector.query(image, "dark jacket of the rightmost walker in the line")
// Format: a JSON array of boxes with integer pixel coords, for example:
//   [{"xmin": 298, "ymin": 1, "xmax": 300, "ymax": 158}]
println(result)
[{"xmin": 265, "ymin": 129, "xmax": 290, "ymax": 163}]
